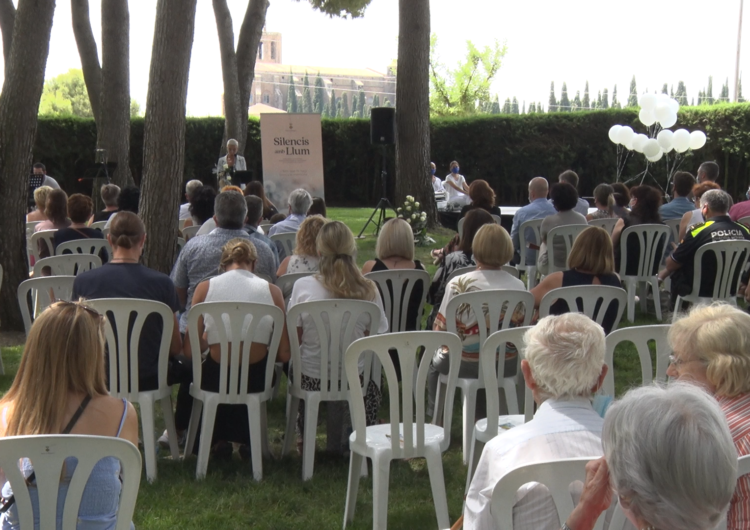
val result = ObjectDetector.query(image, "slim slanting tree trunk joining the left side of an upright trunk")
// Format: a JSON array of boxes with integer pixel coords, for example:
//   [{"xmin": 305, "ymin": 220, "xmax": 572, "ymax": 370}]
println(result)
[{"xmin": 70, "ymin": 0, "xmax": 107, "ymax": 125}]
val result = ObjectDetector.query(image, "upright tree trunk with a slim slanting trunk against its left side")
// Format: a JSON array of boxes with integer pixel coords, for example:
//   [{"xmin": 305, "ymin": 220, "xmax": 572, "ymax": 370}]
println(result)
[{"xmin": 99, "ymin": 0, "xmax": 133, "ymax": 189}]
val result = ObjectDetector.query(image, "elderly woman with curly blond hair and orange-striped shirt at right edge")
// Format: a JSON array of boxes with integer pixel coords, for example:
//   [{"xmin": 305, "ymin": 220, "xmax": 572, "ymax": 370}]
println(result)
[{"xmin": 667, "ymin": 304, "xmax": 750, "ymax": 530}]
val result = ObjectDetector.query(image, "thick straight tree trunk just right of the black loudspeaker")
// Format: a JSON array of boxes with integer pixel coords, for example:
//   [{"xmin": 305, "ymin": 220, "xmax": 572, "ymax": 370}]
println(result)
[{"xmin": 396, "ymin": 0, "xmax": 437, "ymax": 226}]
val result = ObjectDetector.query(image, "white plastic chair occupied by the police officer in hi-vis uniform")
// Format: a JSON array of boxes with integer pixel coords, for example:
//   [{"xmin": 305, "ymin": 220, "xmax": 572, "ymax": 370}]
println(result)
[{"xmin": 672, "ymin": 240, "xmax": 750, "ymax": 320}]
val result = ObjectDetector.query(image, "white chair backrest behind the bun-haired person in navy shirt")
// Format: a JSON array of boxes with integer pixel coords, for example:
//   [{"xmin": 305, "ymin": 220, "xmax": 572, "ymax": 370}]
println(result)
[{"xmin": 86, "ymin": 298, "xmax": 174, "ymax": 401}]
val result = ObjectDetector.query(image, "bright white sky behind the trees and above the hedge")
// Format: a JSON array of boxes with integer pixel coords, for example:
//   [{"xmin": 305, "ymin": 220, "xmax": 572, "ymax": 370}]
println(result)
[{"xmin": 0, "ymin": 0, "xmax": 750, "ymax": 116}]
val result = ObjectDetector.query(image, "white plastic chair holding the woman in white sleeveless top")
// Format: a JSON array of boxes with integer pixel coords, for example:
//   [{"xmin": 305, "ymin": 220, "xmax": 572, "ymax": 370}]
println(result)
[{"xmin": 185, "ymin": 302, "xmax": 284, "ymax": 481}]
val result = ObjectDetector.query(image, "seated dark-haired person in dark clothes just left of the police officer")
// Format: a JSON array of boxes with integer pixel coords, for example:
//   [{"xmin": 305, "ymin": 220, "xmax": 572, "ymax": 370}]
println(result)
[{"xmin": 612, "ymin": 185, "xmax": 667, "ymax": 275}]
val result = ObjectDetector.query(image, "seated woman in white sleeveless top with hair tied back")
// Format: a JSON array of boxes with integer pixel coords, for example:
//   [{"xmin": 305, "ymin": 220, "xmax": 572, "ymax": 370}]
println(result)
[{"xmin": 185, "ymin": 239, "xmax": 290, "ymax": 455}]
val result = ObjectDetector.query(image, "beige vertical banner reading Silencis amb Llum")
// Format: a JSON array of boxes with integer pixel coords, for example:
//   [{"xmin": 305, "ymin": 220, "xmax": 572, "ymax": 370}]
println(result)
[{"xmin": 260, "ymin": 113, "xmax": 325, "ymax": 213}]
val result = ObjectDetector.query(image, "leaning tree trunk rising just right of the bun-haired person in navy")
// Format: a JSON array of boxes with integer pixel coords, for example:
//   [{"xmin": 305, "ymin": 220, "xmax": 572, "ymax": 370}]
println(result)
[{"xmin": 140, "ymin": 0, "xmax": 197, "ymax": 273}]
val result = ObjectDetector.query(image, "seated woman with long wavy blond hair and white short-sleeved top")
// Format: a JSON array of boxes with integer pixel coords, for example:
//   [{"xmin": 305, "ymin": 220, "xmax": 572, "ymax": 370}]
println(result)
[{"xmin": 289, "ymin": 221, "xmax": 388, "ymax": 452}]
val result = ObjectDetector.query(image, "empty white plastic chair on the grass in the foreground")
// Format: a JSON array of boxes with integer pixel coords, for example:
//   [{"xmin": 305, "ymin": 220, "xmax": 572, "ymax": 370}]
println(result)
[{"xmin": 344, "ymin": 331, "xmax": 461, "ymax": 530}]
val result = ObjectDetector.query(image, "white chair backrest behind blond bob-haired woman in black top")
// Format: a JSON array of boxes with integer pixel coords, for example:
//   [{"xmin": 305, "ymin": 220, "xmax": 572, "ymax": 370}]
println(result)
[{"xmin": 365, "ymin": 269, "xmax": 431, "ymax": 332}]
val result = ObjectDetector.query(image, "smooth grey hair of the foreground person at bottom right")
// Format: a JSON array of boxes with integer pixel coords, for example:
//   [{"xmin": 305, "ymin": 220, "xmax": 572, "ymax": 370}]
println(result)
[{"xmin": 602, "ymin": 383, "xmax": 737, "ymax": 530}]
